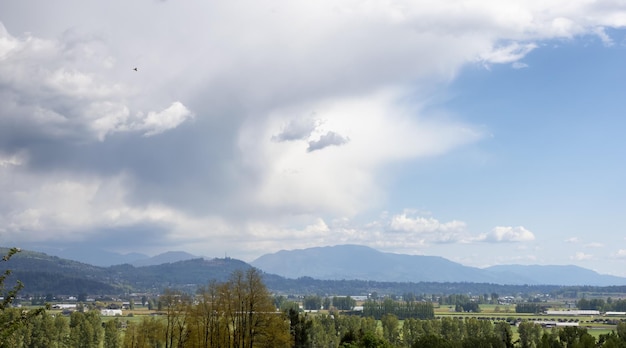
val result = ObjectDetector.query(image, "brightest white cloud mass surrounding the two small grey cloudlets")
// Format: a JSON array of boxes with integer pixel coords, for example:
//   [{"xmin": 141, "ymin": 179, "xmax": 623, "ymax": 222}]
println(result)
[{"xmin": 238, "ymin": 90, "xmax": 483, "ymax": 216}]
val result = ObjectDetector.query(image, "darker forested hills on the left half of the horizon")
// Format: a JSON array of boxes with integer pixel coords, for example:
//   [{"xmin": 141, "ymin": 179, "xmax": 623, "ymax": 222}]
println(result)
[{"xmin": 0, "ymin": 248, "xmax": 251, "ymax": 295}]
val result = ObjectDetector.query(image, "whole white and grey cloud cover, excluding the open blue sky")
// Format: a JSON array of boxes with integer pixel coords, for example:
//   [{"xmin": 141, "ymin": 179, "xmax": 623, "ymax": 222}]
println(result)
[{"xmin": 0, "ymin": 0, "xmax": 626, "ymax": 266}]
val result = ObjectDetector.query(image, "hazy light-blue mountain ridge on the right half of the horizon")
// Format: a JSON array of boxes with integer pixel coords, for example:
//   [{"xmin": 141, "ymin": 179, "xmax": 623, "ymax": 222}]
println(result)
[{"xmin": 251, "ymin": 245, "xmax": 626, "ymax": 286}]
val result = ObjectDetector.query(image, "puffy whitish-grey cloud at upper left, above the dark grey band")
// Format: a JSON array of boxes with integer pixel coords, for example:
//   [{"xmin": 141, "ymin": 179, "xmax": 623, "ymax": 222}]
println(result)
[{"xmin": 0, "ymin": 23, "xmax": 192, "ymax": 141}]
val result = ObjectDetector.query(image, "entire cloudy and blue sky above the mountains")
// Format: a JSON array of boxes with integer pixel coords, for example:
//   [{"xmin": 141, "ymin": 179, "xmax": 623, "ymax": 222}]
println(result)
[{"xmin": 0, "ymin": 0, "xmax": 626, "ymax": 276}]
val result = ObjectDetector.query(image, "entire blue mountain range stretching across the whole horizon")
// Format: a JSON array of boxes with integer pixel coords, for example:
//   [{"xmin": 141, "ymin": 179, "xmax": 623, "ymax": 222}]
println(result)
[{"xmin": 0, "ymin": 245, "xmax": 626, "ymax": 294}]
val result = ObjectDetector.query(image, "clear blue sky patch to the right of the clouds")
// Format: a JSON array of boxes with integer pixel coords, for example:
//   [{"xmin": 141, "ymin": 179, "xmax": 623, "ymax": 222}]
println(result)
[{"xmin": 386, "ymin": 37, "xmax": 626, "ymax": 274}]
